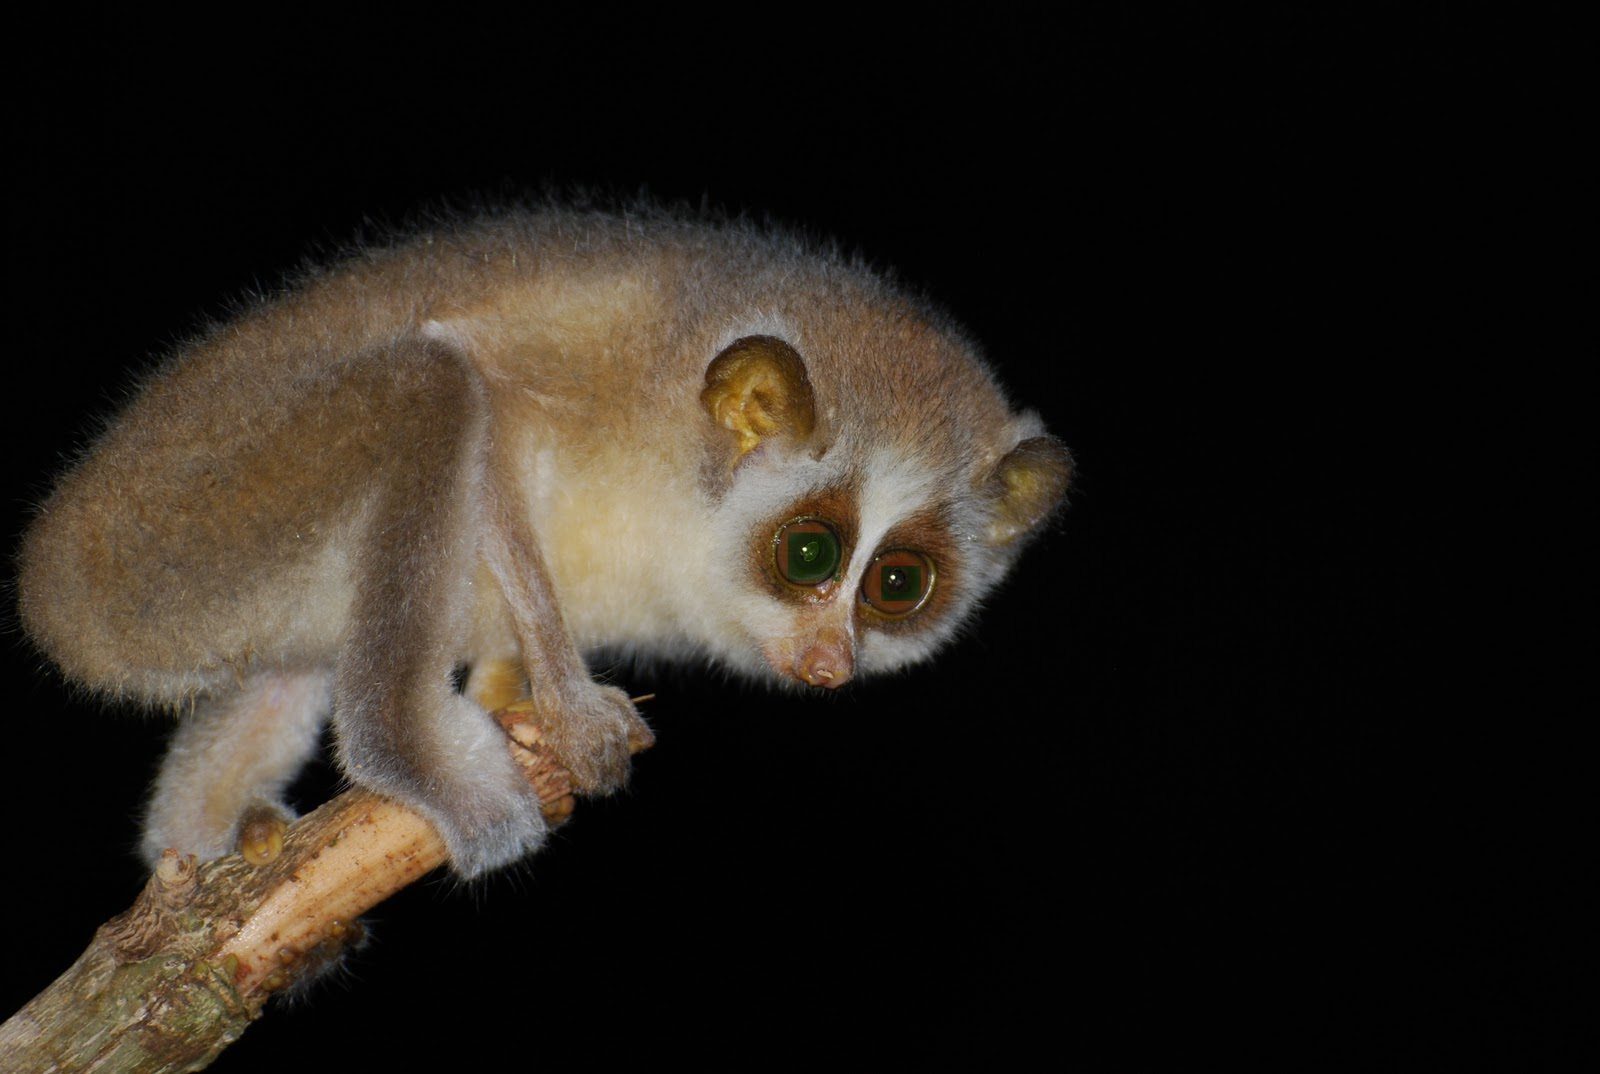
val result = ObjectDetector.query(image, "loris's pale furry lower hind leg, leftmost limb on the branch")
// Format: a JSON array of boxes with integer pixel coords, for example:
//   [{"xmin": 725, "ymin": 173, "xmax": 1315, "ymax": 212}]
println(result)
[{"xmin": 139, "ymin": 672, "xmax": 331, "ymax": 868}]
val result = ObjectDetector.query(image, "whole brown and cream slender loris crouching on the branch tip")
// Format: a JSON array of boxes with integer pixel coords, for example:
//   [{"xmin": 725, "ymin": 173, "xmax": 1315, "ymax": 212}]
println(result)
[{"xmin": 19, "ymin": 211, "xmax": 1070, "ymax": 877}]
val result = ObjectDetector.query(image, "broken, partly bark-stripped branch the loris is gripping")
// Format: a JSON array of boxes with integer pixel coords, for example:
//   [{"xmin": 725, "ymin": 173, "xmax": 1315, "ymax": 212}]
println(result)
[{"xmin": 0, "ymin": 703, "xmax": 636, "ymax": 1074}]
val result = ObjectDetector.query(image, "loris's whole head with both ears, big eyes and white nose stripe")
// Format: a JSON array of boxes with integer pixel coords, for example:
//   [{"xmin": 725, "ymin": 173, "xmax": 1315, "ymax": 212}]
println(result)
[{"xmin": 701, "ymin": 309, "xmax": 1072, "ymax": 687}]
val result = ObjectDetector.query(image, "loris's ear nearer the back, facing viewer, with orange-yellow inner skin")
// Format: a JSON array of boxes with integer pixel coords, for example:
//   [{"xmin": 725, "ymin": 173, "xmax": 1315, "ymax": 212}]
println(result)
[{"xmin": 701, "ymin": 336, "xmax": 816, "ymax": 459}]
